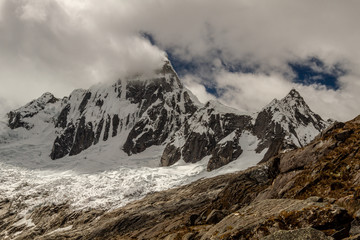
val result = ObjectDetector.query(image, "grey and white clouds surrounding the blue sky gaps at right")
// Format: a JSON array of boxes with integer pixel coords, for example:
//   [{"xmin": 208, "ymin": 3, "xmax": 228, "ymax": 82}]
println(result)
[{"xmin": 129, "ymin": 0, "xmax": 360, "ymax": 120}]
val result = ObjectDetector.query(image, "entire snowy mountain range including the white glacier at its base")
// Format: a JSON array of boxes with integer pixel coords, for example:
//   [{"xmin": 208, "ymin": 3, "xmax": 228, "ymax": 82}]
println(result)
[{"xmin": 0, "ymin": 62, "xmax": 334, "ymax": 227}]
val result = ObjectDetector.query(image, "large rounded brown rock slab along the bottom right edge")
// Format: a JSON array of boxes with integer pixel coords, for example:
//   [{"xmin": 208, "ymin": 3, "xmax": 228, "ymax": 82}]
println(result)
[{"xmin": 201, "ymin": 199, "xmax": 351, "ymax": 239}]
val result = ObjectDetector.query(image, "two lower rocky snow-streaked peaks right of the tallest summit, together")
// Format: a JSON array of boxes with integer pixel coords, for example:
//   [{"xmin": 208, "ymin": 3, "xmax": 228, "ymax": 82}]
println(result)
[{"xmin": 161, "ymin": 89, "xmax": 329, "ymax": 170}]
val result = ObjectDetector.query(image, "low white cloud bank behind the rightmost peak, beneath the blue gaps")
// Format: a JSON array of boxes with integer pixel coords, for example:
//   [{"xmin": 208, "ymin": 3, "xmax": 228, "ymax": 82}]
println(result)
[{"xmin": 211, "ymin": 72, "xmax": 360, "ymax": 121}]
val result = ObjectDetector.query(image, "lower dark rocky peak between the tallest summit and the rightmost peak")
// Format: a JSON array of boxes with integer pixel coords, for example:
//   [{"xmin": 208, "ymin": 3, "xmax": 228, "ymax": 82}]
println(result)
[{"xmin": 162, "ymin": 102, "xmax": 251, "ymax": 171}]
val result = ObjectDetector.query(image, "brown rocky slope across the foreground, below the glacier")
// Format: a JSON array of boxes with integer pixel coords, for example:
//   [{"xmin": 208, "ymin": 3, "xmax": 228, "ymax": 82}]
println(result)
[{"xmin": 0, "ymin": 116, "xmax": 360, "ymax": 239}]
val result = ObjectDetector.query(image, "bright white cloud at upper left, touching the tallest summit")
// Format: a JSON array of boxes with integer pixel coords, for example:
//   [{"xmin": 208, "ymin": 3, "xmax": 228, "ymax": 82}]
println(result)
[{"xmin": 0, "ymin": 0, "xmax": 165, "ymax": 104}]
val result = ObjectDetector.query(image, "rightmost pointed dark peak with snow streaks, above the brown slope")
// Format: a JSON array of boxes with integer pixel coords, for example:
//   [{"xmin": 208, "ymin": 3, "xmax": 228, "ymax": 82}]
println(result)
[{"xmin": 253, "ymin": 89, "xmax": 331, "ymax": 162}]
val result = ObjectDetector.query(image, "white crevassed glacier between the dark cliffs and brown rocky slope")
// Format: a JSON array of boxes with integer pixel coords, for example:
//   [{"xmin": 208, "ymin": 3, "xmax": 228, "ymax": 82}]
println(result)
[{"xmin": 0, "ymin": 111, "xmax": 263, "ymax": 212}]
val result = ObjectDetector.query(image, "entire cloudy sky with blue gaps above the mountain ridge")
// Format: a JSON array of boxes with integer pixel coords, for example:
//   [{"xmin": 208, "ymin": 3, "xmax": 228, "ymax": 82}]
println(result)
[{"xmin": 0, "ymin": 0, "xmax": 360, "ymax": 120}]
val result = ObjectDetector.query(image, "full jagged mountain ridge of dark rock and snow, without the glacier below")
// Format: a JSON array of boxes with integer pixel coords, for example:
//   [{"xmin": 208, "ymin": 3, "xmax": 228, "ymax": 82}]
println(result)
[{"xmin": 2, "ymin": 61, "xmax": 329, "ymax": 171}]
